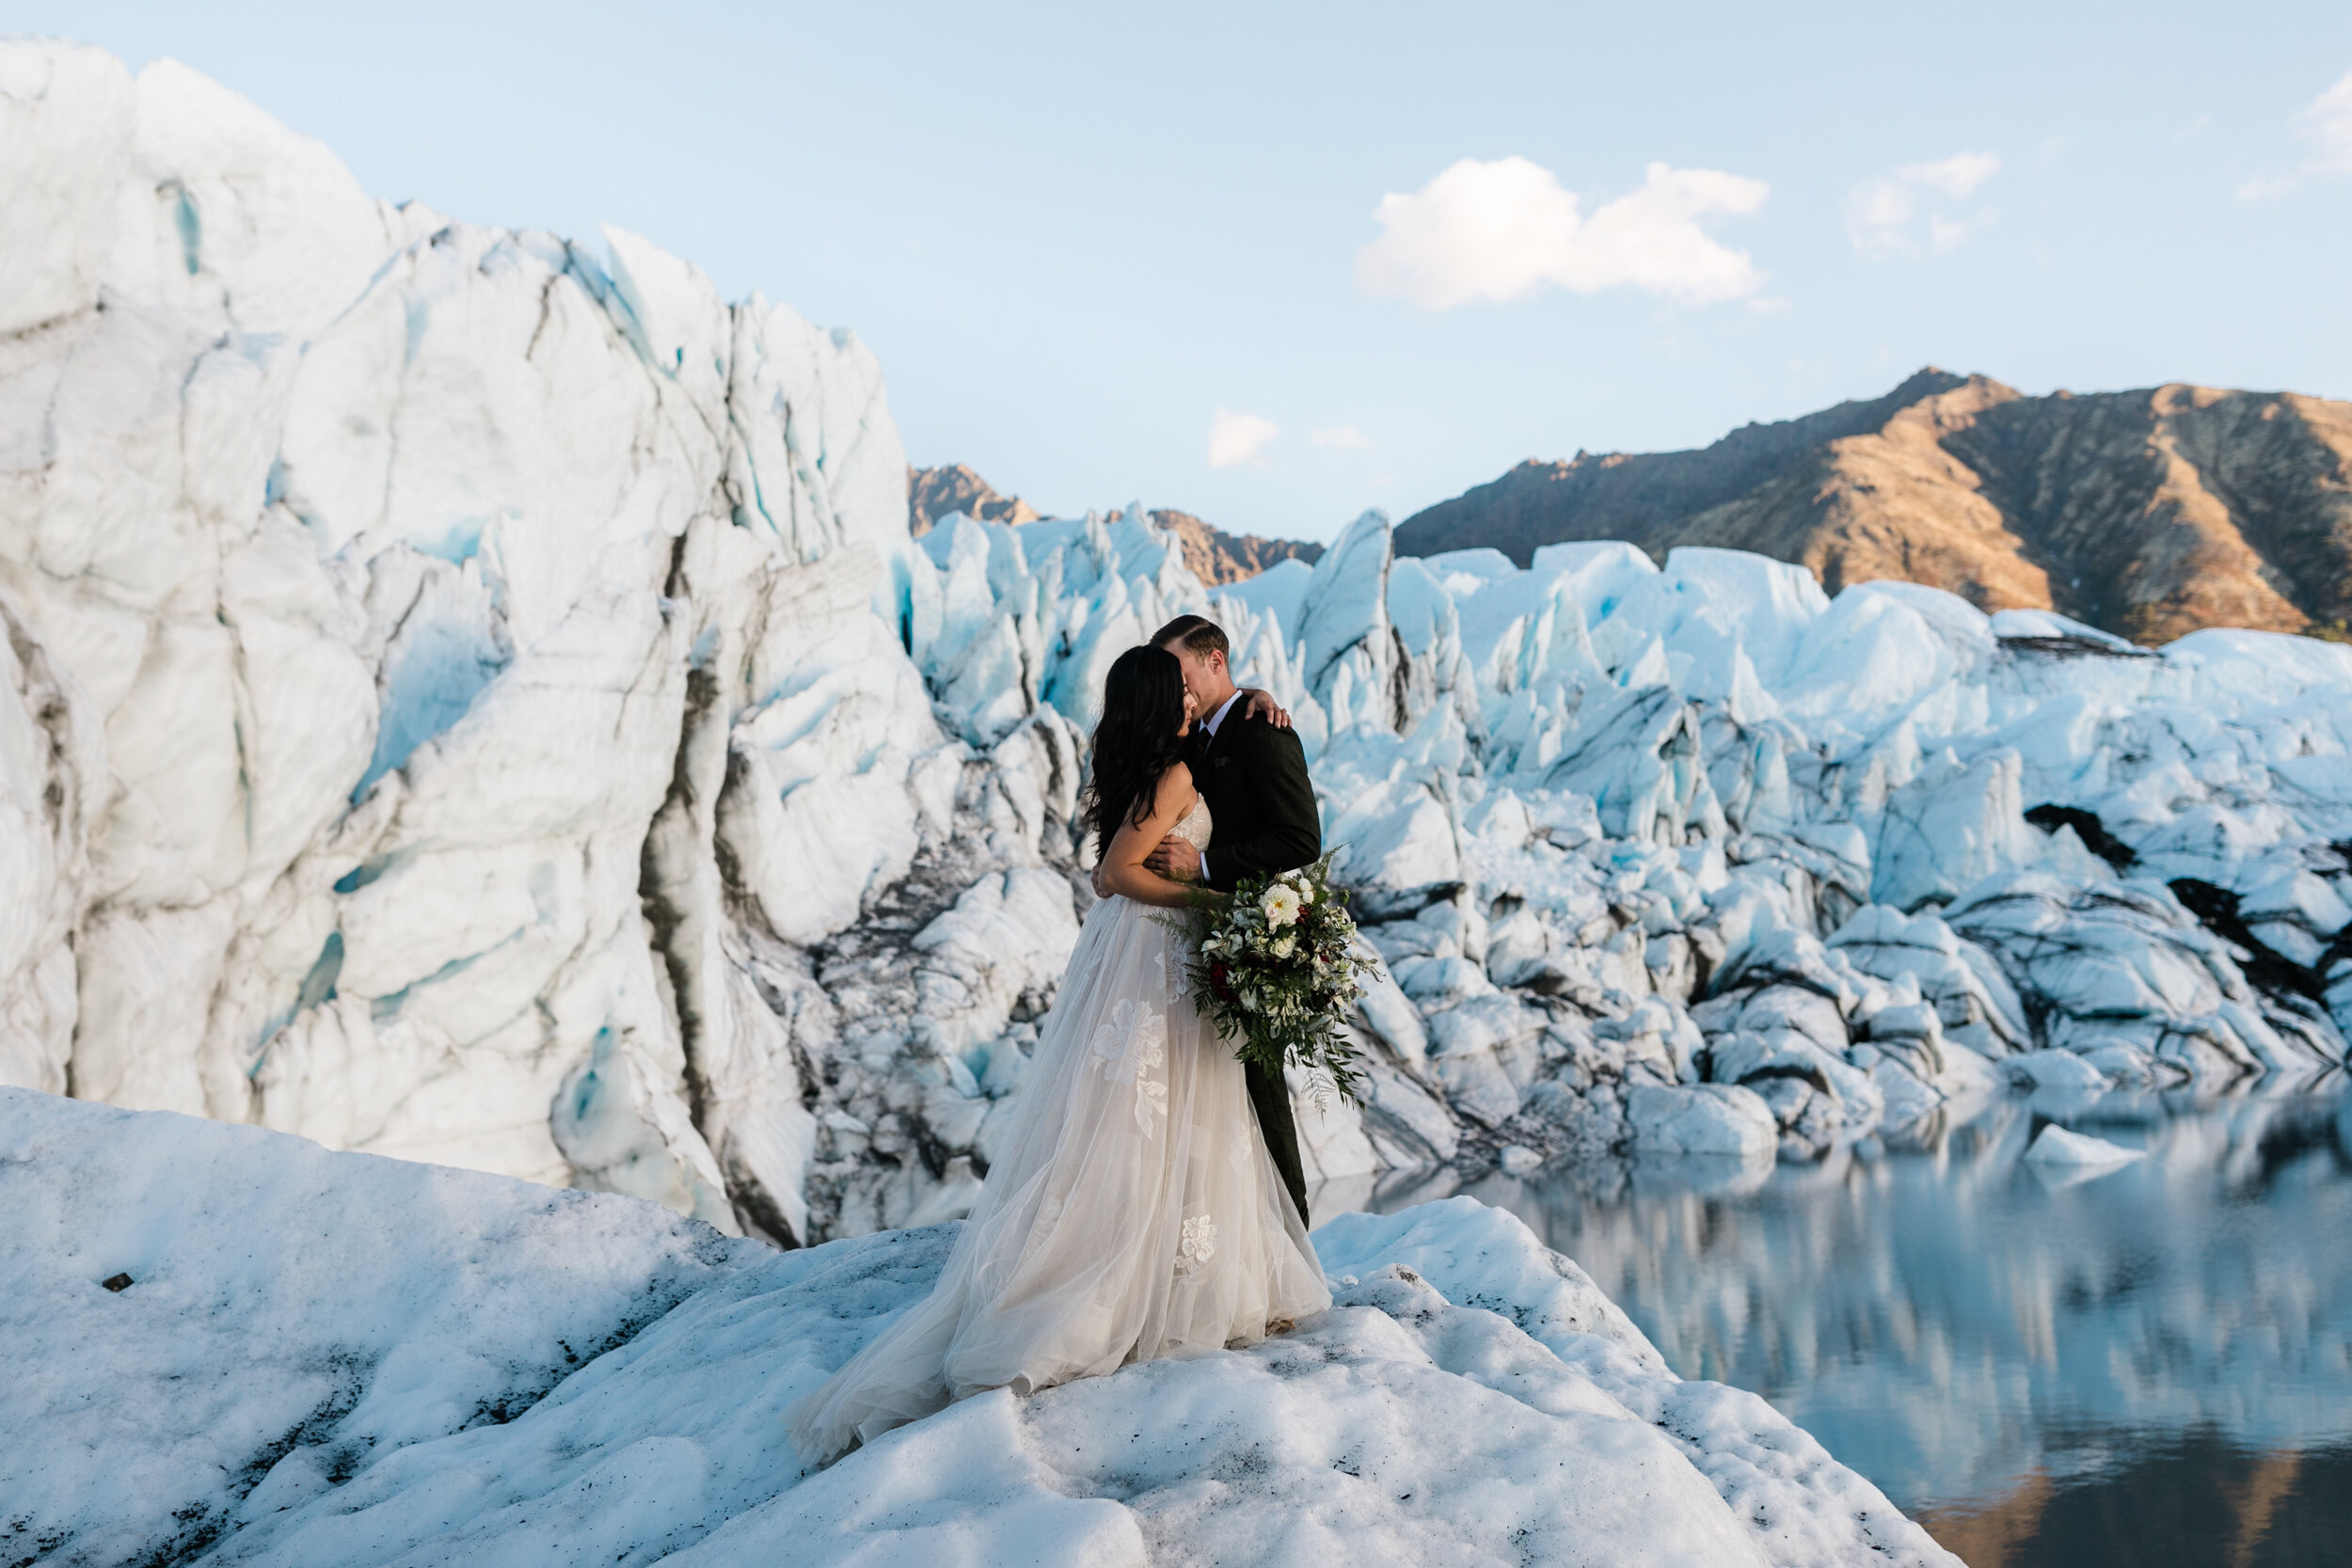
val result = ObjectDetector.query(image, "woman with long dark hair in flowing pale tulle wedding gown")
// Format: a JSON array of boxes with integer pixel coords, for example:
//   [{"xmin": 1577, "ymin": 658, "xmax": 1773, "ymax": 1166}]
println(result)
[{"xmin": 786, "ymin": 646, "xmax": 1331, "ymax": 1463}]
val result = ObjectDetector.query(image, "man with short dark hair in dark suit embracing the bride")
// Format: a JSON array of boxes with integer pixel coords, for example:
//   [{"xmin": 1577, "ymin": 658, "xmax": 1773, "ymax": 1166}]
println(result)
[{"xmin": 1146, "ymin": 616, "xmax": 1322, "ymax": 1225}]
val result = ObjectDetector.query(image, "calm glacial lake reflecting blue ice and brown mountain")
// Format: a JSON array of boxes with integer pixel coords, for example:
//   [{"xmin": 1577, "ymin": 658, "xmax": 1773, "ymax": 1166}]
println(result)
[{"xmin": 1325, "ymin": 1074, "xmax": 2352, "ymax": 1568}]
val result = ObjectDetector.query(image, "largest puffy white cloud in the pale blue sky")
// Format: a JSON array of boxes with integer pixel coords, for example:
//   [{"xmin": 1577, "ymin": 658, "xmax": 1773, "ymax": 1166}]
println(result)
[{"xmin": 1355, "ymin": 157, "xmax": 1772, "ymax": 310}]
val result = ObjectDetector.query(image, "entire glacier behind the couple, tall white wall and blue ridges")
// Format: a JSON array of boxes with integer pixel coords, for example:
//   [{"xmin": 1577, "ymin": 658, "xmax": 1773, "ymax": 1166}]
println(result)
[{"xmin": 0, "ymin": 42, "xmax": 2352, "ymax": 1242}]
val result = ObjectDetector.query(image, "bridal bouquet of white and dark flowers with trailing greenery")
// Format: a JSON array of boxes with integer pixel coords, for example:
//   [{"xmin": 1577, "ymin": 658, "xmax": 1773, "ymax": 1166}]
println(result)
[{"xmin": 1193, "ymin": 856, "xmax": 1374, "ymax": 1105}]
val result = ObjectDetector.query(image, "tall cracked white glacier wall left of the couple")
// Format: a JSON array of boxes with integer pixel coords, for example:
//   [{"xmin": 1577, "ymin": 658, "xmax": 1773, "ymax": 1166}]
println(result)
[{"xmin": 0, "ymin": 42, "xmax": 936, "ymax": 1229}]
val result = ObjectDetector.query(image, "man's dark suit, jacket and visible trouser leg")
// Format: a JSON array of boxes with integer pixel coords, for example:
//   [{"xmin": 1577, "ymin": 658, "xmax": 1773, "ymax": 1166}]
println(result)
[{"xmin": 1185, "ymin": 703, "xmax": 1322, "ymax": 1223}]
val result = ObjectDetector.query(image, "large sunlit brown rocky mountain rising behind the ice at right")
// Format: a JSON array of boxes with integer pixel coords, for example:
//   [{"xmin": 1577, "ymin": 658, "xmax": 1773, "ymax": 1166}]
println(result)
[{"xmin": 1397, "ymin": 367, "xmax": 2352, "ymax": 644}]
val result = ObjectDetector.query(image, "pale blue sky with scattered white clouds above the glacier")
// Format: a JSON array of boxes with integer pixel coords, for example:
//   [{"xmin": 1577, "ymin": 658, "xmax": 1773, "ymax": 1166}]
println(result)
[{"xmin": 32, "ymin": 0, "xmax": 2352, "ymax": 538}]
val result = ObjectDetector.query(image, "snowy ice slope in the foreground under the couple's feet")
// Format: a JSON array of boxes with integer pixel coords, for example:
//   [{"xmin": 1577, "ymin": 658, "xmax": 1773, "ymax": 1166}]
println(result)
[{"xmin": 0, "ymin": 1091, "xmax": 1952, "ymax": 1568}]
